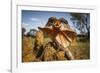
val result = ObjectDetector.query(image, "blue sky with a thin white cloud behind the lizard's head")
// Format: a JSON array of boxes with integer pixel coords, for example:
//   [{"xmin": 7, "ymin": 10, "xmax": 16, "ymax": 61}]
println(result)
[{"xmin": 22, "ymin": 10, "xmax": 78, "ymax": 32}]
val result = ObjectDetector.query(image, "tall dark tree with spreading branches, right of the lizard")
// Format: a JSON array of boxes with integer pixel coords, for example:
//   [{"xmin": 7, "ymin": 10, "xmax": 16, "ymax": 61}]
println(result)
[{"xmin": 70, "ymin": 13, "xmax": 90, "ymax": 38}]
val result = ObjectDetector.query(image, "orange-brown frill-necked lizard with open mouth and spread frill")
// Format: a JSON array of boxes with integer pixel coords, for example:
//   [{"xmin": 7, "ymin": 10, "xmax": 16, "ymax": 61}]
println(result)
[{"xmin": 38, "ymin": 17, "xmax": 76, "ymax": 60}]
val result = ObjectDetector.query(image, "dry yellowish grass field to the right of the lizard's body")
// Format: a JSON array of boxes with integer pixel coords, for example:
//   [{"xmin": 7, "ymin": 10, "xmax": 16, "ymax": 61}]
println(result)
[{"xmin": 70, "ymin": 41, "xmax": 90, "ymax": 60}]
